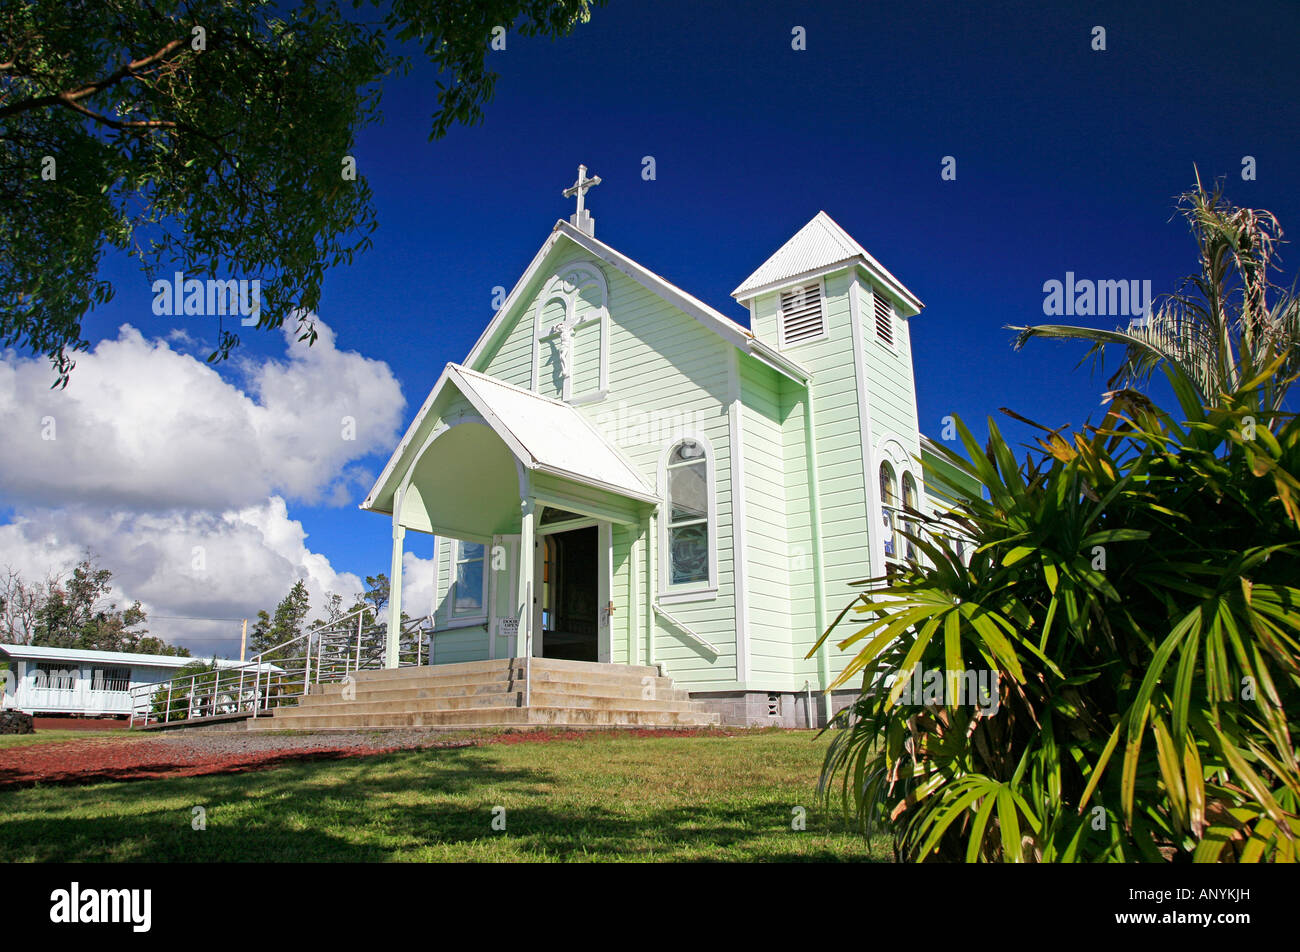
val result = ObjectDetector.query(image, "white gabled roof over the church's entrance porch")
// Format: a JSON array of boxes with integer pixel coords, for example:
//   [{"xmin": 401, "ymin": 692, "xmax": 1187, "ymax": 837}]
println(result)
[{"xmin": 361, "ymin": 364, "xmax": 658, "ymax": 514}]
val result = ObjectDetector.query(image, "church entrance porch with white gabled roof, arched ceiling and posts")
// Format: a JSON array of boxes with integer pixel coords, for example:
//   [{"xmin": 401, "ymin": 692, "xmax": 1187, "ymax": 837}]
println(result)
[{"xmin": 363, "ymin": 365, "xmax": 659, "ymax": 667}]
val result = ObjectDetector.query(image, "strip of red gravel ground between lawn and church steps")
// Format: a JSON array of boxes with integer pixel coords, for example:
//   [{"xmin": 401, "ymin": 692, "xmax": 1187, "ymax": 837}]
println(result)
[{"xmin": 0, "ymin": 730, "xmax": 727, "ymax": 791}]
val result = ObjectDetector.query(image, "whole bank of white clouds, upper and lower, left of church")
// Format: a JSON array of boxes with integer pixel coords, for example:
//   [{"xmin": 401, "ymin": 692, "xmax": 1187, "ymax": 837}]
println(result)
[{"xmin": 0, "ymin": 319, "xmax": 416, "ymax": 657}]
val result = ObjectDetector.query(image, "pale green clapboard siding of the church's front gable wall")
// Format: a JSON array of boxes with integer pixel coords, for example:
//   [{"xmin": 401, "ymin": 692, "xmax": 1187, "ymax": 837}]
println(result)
[{"xmin": 467, "ymin": 242, "xmax": 736, "ymax": 688}]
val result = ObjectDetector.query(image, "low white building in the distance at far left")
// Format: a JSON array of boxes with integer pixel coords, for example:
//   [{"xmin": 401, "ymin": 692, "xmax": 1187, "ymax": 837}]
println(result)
[{"xmin": 0, "ymin": 644, "xmax": 239, "ymax": 717}]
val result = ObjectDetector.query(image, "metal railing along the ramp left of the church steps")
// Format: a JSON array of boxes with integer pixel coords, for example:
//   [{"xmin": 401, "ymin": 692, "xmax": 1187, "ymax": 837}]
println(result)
[{"xmin": 130, "ymin": 609, "xmax": 433, "ymax": 727}]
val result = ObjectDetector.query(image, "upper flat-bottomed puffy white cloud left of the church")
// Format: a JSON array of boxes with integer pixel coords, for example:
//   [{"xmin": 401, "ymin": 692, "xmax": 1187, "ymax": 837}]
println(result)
[{"xmin": 0, "ymin": 319, "xmax": 404, "ymax": 511}]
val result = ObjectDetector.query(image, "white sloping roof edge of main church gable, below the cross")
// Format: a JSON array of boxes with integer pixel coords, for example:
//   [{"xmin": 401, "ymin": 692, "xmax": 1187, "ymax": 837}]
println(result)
[{"xmin": 464, "ymin": 221, "xmax": 810, "ymax": 384}]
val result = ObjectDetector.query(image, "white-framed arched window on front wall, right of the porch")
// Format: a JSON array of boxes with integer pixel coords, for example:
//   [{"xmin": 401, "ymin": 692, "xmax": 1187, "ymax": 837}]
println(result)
[{"xmin": 664, "ymin": 440, "xmax": 714, "ymax": 590}]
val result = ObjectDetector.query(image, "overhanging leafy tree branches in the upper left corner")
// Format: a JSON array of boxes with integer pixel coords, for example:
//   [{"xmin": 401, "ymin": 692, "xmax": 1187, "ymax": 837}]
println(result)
[{"xmin": 0, "ymin": 0, "xmax": 602, "ymax": 385}]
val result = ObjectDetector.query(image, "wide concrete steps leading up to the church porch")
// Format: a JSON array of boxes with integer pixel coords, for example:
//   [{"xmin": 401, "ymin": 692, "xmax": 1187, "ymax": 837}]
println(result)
[{"xmin": 248, "ymin": 658, "xmax": 719, "ymax": 731}]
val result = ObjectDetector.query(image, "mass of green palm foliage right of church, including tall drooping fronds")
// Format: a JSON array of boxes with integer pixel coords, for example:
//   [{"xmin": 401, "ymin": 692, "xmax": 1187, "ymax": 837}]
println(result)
[{"xmin": 809, "ymin": 183, "xmax": 1300, "ymax": 861}]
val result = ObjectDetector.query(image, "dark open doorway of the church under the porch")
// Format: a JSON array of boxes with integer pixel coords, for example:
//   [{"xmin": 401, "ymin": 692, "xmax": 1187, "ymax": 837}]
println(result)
[{"xmin": 541, "ymin": 525, "xmax": 601, "ymax": 661}]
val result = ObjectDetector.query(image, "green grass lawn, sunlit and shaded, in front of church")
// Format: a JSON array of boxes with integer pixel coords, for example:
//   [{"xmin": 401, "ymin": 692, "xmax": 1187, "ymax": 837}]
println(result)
[{"xmin": 0, "ymin": 731, "xmax": 888, "ymax": 862}]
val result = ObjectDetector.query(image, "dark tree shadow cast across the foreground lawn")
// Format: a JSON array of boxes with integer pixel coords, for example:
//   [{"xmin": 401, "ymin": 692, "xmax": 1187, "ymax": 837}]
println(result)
[{"xmin": 0, "ymin": 748, "xmax": 881, "ymax": 862}]
